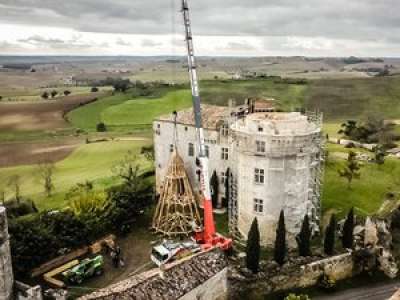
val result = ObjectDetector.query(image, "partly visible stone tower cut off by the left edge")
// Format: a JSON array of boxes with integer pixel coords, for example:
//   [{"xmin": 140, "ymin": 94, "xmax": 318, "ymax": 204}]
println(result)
[{"xmin": 0, "ymin": 206, "xmax": 14, "ymax": 300}]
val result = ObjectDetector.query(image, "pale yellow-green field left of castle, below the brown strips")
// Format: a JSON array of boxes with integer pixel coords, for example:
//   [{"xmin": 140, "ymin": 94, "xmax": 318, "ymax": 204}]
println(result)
[{"xmin": 0, "ymin": 141, "xmax": 149, "ymax": 209}]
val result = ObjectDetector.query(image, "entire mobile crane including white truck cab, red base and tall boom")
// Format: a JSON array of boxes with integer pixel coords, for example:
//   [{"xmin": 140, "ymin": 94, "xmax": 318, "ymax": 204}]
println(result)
[{"xmin": 151, "ymin": 0, "xmax": 232, "ymax": 266}]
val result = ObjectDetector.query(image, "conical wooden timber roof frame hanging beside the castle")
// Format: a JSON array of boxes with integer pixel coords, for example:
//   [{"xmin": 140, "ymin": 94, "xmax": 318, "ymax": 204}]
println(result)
[{"xmin": 152, "ymin": 147, "xmax": 201, "ymax": 237}]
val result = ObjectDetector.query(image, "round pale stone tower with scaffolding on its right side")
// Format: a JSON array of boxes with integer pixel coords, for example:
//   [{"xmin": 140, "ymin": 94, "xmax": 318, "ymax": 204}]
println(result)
[{"xmin": 231, "ymin": 112, "xmax": 322, "ymax": 245}]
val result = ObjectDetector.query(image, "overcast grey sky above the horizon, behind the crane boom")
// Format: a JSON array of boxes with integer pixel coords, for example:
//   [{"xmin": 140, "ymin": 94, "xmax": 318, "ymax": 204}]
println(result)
[{"xmin": 0, "ymin": 0, "xmax": 400, "ymax": 57}]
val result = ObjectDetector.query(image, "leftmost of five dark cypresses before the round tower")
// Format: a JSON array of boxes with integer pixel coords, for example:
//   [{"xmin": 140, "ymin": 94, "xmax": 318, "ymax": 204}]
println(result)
[{"xmin": 246, "ymin": 218, "xmax": 260, "ymax": 273}]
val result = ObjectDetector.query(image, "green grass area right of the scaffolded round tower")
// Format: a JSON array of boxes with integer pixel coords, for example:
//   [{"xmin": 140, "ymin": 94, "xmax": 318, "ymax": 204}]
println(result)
[{"xmin": 322, "ymin": 144, "xmax": 400, "ymax": 216}]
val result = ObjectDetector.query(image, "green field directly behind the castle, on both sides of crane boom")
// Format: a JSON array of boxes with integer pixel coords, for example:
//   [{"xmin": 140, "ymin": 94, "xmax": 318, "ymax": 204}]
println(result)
[{"xmin": 67, "ymin": 80, "xmax": 307, "ymax": 132}]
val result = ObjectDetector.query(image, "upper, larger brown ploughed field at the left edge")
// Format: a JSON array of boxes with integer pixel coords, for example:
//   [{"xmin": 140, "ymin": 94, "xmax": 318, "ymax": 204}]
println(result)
[{"xmin": 0, "ymin": 93, "xmax": 103, "ymax": 131}]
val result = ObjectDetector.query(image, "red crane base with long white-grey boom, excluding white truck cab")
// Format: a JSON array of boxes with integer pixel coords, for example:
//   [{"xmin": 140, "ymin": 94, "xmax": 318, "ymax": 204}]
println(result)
[{"xmin": 182, "ymin": 0, "xmax": 232, "ymax": 250}]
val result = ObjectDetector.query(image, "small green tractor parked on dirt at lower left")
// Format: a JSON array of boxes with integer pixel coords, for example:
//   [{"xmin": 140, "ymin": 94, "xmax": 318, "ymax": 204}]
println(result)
[{"xmin": 62, "ymin": 255, "xmax": 104, "ymax": 284}]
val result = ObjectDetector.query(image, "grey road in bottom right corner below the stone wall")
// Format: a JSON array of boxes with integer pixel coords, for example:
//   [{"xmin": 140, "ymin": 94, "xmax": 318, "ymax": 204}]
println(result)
[{"xmin": 312, "ymin": 281, "xmax": 400, "ymax": 300}]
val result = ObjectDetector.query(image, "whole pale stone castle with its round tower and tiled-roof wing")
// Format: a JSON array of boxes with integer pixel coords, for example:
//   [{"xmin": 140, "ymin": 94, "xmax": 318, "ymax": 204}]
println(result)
[{"xmin": 153, "ymin": 99, "xmax": 323, "ymax": 245}]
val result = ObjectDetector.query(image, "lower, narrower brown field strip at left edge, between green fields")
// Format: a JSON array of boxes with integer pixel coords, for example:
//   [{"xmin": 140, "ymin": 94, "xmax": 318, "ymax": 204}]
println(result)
[{"xmin": 0, "ymin": 138, "xmax": 82, "ymax": 168}]
